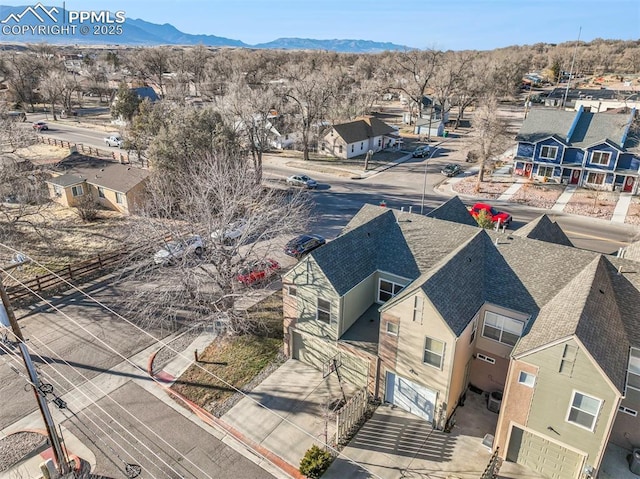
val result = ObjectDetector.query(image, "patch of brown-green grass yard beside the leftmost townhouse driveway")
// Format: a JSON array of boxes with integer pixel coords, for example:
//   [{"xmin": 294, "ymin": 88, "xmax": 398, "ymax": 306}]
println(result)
[{"xmin": 172, "ymin": 291, "xmax": 284, "ymax": 416}]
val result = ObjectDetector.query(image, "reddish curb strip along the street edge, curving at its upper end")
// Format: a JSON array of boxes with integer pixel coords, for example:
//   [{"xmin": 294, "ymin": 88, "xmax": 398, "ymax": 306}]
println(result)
[{"xmin": 147, "ymin": 351, "xmax": 307, "ymax": 479}]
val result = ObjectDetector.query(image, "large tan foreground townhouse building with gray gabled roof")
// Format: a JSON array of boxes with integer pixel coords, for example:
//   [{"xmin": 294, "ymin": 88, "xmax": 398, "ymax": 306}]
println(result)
[{"xmin": 283, "ymin": 200, "xmax": 640, "ymax": 479}]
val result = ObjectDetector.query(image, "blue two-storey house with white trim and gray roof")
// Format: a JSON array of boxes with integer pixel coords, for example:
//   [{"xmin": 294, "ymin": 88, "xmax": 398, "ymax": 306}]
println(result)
[{"xmin": 514, "ymin": 108, "xmax": 640, "ymax": 194}]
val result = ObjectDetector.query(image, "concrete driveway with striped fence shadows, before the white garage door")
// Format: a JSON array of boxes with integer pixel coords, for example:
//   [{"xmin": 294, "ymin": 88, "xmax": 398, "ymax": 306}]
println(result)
[{"xmin": 322, "ymin": 393, "xmax": 539, "ymax": 479}]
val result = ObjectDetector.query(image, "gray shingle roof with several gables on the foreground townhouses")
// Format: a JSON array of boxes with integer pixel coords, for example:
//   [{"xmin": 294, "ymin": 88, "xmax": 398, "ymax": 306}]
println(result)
[{"xmin": 304, "ymin": 201, "xmax": 640, "ymax": 388}]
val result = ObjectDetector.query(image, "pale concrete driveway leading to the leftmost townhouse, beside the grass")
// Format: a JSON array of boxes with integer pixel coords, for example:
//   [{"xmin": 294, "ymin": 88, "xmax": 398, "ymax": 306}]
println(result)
[{"xmin": 222, "ymin": 359, "xmax": 356, "ymax": 468}]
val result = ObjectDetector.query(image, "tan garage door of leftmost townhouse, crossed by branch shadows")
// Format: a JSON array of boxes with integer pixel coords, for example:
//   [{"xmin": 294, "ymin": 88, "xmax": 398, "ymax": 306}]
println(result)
[{"xmin": 291, "ymin": 332, "xmax": 369, "ymax": 387}]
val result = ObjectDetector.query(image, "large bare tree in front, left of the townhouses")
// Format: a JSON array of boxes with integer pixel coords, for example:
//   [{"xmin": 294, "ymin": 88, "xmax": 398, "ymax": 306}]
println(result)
[{"xmin": 122, "ymin": 149, "xmax": 308, "ymax": 333}]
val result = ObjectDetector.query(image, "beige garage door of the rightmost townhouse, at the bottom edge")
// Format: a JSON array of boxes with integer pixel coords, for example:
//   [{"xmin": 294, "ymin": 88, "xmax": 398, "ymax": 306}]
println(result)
[{"xmin": 507, "ymin": 426, "xmax": 584, "ymax": 479}]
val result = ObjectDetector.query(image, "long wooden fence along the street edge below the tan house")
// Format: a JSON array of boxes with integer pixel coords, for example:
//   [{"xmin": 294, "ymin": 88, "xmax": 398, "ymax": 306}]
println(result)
[{"xmin": 6, "ymin": 247, "xmax": 131, "ymax": 302}]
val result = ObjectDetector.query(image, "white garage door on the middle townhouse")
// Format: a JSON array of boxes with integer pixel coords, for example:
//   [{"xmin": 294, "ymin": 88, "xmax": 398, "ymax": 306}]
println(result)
[{"xmin": 385, "ymin": 372, "xmax": 438, "ymax": 422}]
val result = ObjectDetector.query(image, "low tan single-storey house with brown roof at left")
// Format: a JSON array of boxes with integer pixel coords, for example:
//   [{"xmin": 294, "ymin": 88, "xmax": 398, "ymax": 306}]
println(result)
[{"xmin": 47, "ymin": 153, "xmax": 150, "ymax": 214}]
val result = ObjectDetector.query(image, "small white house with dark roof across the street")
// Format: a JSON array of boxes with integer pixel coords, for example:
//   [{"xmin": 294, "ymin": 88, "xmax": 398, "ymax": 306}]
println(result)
[{"xmin": 319, "ymin": 116, "xmax": 400, "ymax": 159}]
